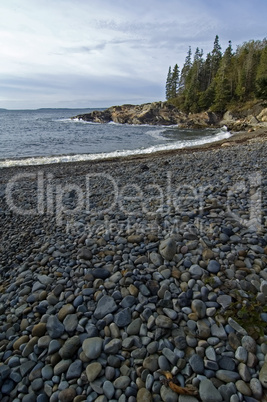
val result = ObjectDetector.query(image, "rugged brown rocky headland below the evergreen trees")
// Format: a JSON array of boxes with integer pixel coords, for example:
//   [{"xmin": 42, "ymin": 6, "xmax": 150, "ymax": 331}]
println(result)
[{"xmin": 73, "ymin": 102, "xmax": 267, "ymax": 131}]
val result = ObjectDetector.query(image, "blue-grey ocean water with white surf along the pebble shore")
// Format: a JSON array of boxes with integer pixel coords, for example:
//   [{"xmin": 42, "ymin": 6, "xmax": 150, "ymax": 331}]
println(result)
[{"xmin": 0, "ymin": 109, "xmax": 231, "ymax": 167}]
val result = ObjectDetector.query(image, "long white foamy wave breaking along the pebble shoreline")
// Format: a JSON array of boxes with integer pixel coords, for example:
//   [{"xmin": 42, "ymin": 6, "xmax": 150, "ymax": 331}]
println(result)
[{"xmin": 0, "ymin": 127, "xmax": 232, "ymax": 168}]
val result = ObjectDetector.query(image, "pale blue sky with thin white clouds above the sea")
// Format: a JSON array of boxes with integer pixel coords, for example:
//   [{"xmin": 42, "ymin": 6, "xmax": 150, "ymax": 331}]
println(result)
[{"xmin": 0, "ymin": 0, "xmax": 267, "ymax": 109}]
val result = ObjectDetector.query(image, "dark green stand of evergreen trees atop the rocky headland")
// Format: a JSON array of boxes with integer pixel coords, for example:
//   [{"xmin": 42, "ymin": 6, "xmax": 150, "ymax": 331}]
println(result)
[{"xmin": 166, "ymin": 35, "xmax": 267, "ymax": 113}]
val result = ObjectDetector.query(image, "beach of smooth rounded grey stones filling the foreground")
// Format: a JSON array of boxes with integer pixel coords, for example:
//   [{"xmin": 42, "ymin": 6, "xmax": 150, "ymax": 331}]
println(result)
[{"xmin": 0, "ymin": 142, "xmax": 267, "ymax": 402}]
